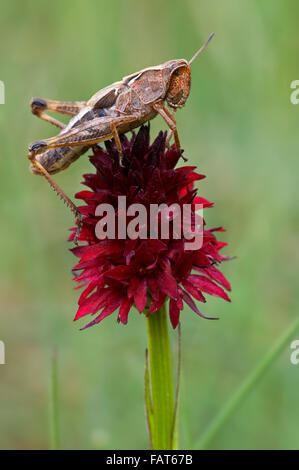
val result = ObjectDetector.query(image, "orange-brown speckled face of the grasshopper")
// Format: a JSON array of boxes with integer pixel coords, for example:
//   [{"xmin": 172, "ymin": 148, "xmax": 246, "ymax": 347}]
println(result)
[{"xmin": 165, "ymin": 59, "xmax": 191, "ymax": 109}]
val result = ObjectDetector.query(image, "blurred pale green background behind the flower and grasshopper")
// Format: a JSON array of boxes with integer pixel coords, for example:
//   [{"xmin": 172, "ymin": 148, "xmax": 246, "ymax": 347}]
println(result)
[{"xmin": 0, "ymin": 0, "xmax": 299, "ymax": 449}]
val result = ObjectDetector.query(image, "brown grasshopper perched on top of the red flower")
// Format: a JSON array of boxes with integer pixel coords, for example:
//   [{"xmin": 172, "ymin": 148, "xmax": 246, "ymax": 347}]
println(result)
[{"xmin": 28, "ymin": 33, "xmax": 214, "ymax": 231}]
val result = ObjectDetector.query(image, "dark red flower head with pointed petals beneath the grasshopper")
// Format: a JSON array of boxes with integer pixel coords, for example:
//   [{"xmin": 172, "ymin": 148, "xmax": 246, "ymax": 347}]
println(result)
[{"xmin": 70, "ymin": 126, "xmax": 230, "ymax": 328}]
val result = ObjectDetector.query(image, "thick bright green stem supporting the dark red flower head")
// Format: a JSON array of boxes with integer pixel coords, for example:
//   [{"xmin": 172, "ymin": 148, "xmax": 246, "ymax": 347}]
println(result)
[{"xmin": 146, "ymin": 305, "xmax": 176, "ymax": 450}]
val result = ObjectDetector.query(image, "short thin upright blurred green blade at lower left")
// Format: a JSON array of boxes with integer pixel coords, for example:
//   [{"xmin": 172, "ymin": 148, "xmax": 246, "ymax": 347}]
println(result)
[{"xmin": 50, "ymin": 350, "xmax": 60, "ymax": 450}]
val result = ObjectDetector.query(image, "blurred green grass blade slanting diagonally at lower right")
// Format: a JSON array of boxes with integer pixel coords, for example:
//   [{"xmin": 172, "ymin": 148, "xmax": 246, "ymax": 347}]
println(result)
[{"xmin": 195, "ymin": 318, "xmax": 299, "ymax": 449}]
